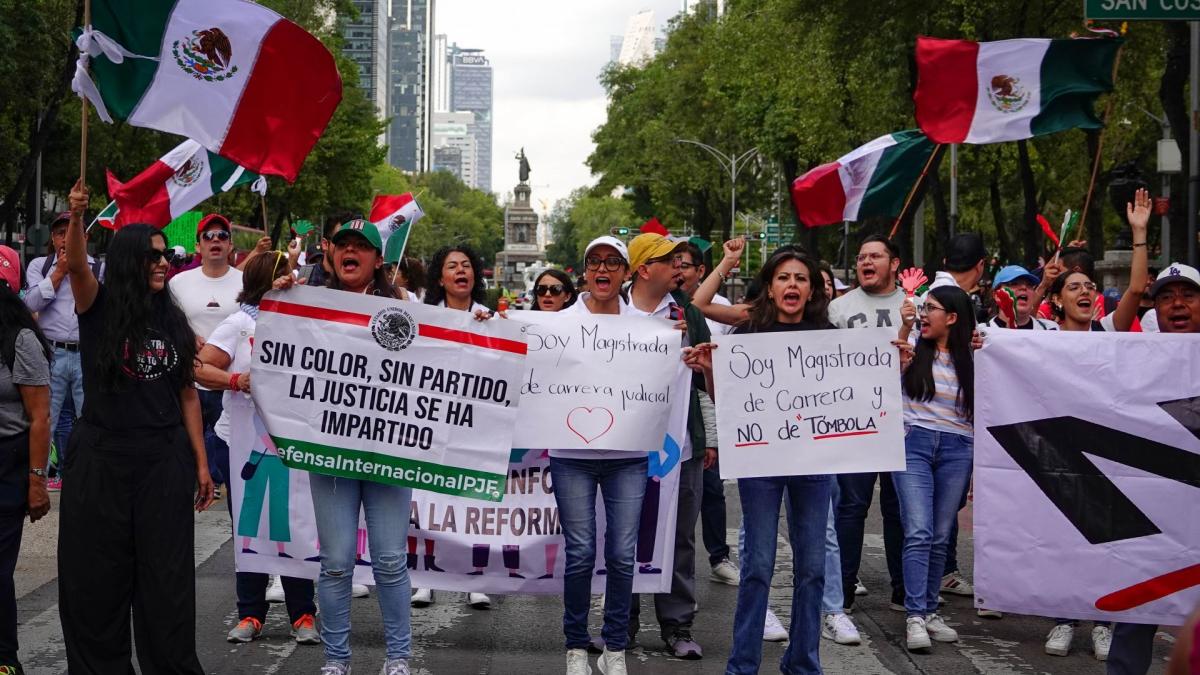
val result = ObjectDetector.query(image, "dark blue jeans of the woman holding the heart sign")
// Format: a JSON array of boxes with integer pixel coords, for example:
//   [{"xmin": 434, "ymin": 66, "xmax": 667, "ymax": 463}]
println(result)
[{"xmin": 550, "ymin": 456, "xmax": 648, "ymax": 651}]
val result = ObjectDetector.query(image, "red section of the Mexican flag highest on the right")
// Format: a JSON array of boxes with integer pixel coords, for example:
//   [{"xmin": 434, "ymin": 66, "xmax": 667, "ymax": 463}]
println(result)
[{"xmin": 912, "ymin": 37, "xmax": 979, "ymax": 143}]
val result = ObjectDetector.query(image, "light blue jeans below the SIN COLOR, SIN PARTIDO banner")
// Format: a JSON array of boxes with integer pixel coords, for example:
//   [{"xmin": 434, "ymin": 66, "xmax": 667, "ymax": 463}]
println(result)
[{"xmin": 308, "ymin": 473, "xmax": 413, "ymax": 662}]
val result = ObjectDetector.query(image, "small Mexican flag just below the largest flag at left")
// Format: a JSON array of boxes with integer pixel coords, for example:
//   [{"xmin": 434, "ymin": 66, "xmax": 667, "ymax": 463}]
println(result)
[{"xmin": 106, "ymin": 141, "xmax": 266, "ymax": 229}]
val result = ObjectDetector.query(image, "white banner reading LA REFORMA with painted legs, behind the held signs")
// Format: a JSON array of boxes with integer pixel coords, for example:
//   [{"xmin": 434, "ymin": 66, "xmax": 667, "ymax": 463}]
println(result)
[{"xmin": 229, "ymin": 400, "xmax": 680, "ymax": 595}]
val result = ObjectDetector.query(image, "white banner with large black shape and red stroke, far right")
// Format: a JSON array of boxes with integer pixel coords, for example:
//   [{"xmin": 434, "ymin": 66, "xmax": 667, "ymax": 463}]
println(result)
[{"xmin": 974, "ymin": 330, "xmax": 1200, "ymax": 626}]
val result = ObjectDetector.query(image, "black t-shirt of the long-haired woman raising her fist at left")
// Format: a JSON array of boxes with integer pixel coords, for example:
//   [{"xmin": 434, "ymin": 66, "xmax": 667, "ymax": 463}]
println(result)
[{"xmin": 79, "ymin": 285, "xmax": 191, "ymax": 431}]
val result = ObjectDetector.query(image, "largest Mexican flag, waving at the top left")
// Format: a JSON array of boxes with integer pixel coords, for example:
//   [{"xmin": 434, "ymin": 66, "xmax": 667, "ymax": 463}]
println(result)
[{"xmin": 72, "ymin": 0, "xmax": 342, "ymax": 183}]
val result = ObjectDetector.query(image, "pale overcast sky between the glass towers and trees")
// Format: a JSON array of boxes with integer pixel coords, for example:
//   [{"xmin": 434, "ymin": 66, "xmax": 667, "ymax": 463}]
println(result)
[{"xmin": 434, "ymin": 0, "xmax": 682, "ymax": 213}]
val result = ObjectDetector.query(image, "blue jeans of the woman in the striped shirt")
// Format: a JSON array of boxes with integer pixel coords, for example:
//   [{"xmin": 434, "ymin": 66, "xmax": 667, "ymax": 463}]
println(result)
[{"xmin": 892, "ymin": 426, "xmax": 974, "ymax": 616}]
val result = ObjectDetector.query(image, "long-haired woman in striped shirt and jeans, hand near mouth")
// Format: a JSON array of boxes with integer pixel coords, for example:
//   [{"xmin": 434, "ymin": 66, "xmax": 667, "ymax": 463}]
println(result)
[{"xmin": 892, "ymin": 286, "xmax": 974, "ymax": 650}]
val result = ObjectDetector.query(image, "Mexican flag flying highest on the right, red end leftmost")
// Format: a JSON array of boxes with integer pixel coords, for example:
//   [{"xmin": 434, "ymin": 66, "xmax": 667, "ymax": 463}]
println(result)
[{"xmin": 913, "ymin": 37, "xmax": 1123, "ymax": 143}]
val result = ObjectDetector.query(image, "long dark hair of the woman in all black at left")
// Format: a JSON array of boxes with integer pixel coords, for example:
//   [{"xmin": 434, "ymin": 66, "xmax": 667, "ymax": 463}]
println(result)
[{"xmin": 97, "ymin": 223, "xmax": 196, "ymax": 392}]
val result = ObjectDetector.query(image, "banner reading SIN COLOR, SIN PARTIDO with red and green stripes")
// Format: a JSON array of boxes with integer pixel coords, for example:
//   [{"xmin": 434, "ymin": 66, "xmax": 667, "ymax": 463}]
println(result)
[{"xmin": 251, "ymin": 286, "xmax": 526, "ymax": 501}]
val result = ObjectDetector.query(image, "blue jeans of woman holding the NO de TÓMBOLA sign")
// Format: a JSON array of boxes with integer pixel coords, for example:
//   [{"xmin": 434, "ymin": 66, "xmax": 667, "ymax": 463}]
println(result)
[{"xmin": 725, "ymin": 476, "xmax": 832, "ymax": 675}]
